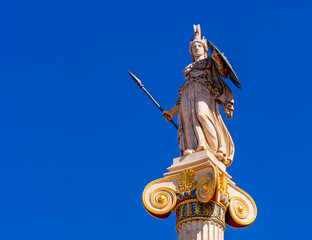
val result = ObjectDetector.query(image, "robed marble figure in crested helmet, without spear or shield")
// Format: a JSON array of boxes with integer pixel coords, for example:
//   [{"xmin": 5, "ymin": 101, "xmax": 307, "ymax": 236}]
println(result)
[{"xmin": 163, "ymin": 25, "xmax": 234, "ymax": 166}]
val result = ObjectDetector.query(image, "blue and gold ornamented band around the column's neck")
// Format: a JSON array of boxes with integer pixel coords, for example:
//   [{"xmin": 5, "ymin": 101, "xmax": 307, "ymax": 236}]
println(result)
[{"xmin": 174, "ymin": 199, "xmax": 225, "ymax": 229}]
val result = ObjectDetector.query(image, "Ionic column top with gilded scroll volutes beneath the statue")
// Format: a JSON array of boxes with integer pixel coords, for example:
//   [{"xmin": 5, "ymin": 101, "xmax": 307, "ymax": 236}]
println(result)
[{"xmin": 142, "ymin": 151, "xmax": 257, "ymax": 240}]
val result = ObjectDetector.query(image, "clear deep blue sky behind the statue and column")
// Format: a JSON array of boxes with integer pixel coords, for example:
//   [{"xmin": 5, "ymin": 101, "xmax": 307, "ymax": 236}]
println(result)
[{"xmin": 0, "ymin": 0, "xmax": 312, "ymax": 240}]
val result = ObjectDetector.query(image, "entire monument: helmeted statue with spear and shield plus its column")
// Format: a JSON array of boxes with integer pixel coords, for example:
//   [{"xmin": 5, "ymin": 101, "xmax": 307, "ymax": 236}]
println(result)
[{"xmin": 140, "ymin": 25, "xmax": 257, "ymax": 240}]
